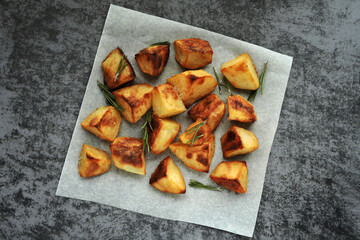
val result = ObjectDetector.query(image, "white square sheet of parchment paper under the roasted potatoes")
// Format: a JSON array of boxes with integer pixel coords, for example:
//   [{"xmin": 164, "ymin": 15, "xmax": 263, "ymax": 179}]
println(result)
[{"xmin": 56, "ymin": 5, "xmax": 292, "ymax": 237}]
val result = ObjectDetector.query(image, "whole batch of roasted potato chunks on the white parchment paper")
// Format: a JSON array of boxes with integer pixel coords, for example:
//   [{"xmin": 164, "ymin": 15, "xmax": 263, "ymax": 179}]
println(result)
[{"xmin": 79, "ymin": 38, "xmax": 259, "ymax": 194}]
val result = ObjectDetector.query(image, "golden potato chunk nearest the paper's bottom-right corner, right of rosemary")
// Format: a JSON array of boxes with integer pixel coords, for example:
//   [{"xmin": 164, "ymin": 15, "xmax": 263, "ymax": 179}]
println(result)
[{"xmin": 210, "ymin": 161, "xmax": 248, "ymax": 193}]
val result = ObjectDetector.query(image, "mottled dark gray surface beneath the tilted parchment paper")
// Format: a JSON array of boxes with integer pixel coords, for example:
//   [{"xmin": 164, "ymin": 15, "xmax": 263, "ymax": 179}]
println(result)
[{"xmin": 0, "ymin": 0, "xmax": 360, "ymax": 239}]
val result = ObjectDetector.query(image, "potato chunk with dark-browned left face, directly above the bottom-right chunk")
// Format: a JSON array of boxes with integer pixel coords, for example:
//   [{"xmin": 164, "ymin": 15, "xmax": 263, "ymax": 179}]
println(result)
[{"xmin": 221, "ymin": 126, "xmax": 259, "ymax": 158}]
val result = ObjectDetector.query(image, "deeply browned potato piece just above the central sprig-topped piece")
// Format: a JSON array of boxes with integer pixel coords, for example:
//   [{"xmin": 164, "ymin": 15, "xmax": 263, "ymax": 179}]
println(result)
[{"xmin": 188, "ymin": 93, "xmax": 226, "ymax": 132}]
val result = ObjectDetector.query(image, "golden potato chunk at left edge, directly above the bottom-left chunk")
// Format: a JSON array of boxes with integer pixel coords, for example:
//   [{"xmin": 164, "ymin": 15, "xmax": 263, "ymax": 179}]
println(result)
[{"xmin": 81, "ymin": 106, "xmax": 121, "ymax": 142}]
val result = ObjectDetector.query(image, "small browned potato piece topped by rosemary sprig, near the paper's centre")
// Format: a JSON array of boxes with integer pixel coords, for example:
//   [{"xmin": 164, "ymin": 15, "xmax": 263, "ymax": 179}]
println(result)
[{"xmin": 179, "ymin": 118, "xmax": 211, "ymax": 146}]
